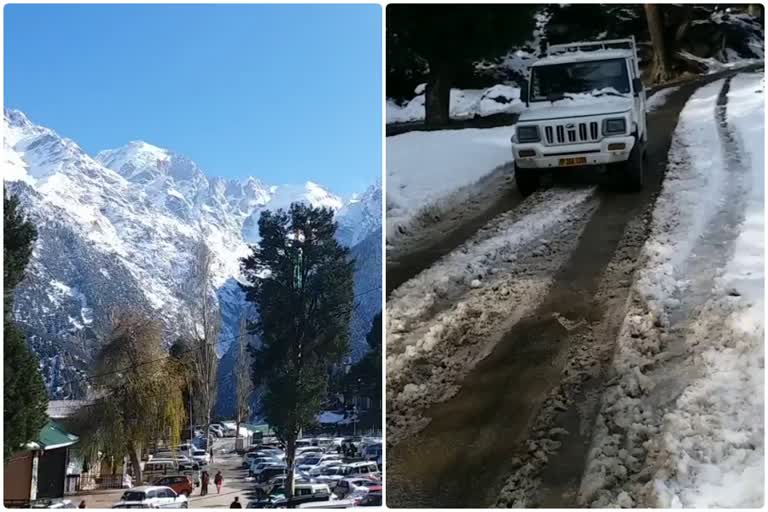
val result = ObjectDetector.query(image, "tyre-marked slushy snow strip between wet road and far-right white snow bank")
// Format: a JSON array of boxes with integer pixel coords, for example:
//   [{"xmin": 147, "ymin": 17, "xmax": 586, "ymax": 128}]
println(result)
[{"xmin": 579, "ymin": 73, "xmax": 746, "ymax": 507}]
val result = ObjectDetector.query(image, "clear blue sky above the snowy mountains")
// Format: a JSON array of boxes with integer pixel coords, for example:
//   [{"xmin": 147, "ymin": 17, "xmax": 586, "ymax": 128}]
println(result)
[{"xmin": 4, "ymin": 5, "xmax": 382, "ymax": 196}]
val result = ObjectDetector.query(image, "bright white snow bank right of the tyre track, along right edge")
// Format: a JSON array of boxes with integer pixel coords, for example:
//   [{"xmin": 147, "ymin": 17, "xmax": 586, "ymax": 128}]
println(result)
[{"xmin": 657, "ymin": 75, "xmax": 765, "ymax": 508}]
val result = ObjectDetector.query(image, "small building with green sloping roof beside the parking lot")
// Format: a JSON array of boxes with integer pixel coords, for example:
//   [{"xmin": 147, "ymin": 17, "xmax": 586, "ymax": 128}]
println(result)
[{"xmin": 3, "ymin": 420, "xmax": 79, "ymax": 506}]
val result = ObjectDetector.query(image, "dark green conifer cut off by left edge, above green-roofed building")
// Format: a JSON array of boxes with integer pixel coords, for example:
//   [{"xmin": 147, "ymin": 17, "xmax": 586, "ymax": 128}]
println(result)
[{"xmin": 3, "ymin": 191, "xmax": 48, "ymax": 461}]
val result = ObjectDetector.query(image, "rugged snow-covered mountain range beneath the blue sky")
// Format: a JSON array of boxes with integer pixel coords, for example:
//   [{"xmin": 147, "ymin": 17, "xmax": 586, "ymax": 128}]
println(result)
[{"xmin": 3, "ymin": 110, "xmax": 381, "ymax": 397}]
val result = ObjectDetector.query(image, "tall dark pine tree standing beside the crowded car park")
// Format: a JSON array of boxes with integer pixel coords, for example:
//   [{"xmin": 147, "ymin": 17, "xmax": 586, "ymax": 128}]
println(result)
[{"xmin": 243, "ymin": 203, "xmax": 354, "ymax": 499}]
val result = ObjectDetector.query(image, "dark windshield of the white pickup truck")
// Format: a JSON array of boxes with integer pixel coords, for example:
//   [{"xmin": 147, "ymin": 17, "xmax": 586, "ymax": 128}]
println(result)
[{"xmin": 531, "ymin": 59, "xmax": 630, "ymax": 101}]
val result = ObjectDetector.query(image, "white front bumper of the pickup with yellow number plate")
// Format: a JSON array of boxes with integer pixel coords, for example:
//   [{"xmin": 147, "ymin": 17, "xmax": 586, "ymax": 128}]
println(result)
[{"xmin": 512, "ymin": 135, "xmax": 635, "ymax": 169}]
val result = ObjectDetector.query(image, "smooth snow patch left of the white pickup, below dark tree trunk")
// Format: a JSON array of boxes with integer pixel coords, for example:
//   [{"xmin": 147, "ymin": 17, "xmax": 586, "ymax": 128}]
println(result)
[{"xmin": 387, "ymin": 126, "xmax": 513, "ymax": 245}]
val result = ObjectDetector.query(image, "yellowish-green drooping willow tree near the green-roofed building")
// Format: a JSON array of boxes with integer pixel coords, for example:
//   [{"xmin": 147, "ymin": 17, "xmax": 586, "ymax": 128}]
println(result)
[{"xmin": 77, "ymin": 311, "xmax": 185, "ymax": 483}]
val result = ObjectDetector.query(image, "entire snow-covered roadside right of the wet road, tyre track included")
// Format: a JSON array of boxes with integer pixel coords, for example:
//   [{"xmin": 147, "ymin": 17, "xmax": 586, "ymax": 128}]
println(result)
[{"xmin": 580, "ymin": 74, "xmax": 764, "ymax": 508}]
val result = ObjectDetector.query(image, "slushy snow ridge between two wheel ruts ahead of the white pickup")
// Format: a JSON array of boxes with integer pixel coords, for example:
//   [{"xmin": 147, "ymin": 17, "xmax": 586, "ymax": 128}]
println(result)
[{"xmin": 387, "ymin": 189, "xmax": 596, "ymax": 443}]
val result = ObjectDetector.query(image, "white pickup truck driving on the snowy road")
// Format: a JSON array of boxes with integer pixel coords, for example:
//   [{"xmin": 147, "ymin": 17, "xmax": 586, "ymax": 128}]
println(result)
[{"xmin": 512, "ymin": 38, "xmax": 648, "ymax": 195}]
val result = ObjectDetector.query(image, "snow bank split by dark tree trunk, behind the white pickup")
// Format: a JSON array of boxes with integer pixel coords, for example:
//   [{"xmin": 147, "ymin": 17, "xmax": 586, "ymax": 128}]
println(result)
[{"xmin": 387, "ymin": 84, "xmax": 525, "ymax": 123}]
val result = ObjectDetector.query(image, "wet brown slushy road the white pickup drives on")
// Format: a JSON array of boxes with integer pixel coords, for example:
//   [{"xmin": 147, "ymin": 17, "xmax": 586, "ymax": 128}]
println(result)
[{"xmin": 387, "ymin": 67, "xmax": 760, "ymax": 508}]
